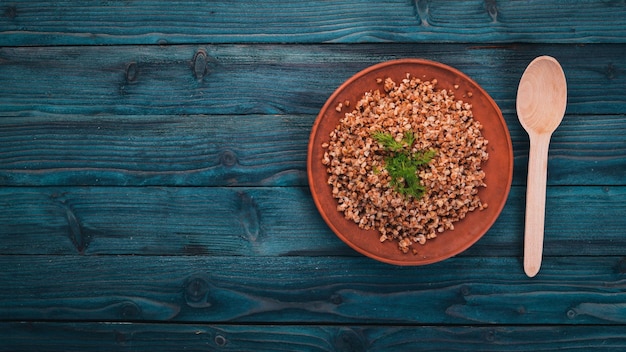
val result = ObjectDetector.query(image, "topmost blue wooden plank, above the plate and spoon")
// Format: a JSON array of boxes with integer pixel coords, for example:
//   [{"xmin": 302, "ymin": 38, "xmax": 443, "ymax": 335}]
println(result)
[{"xmin": 0, "ymin": 0, "xmax": 626, "ymax": 46}]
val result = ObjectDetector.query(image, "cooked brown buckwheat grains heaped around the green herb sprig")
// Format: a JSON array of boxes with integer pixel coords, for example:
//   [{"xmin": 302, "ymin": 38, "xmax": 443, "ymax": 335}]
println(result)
[{"xmin": 322, "ymin": 74, "xmax": 488, "ymax": 253}]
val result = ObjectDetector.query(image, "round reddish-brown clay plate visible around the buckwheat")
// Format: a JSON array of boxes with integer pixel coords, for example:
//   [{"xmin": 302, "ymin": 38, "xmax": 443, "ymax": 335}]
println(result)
[{"xmin": 307, "ymin": 59, "xmax": 513, "ymax": 265}]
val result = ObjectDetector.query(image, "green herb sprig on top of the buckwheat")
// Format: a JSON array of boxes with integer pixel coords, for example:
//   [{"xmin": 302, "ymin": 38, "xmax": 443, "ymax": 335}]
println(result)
[{"xmin": 372, "ymin": 131, "xmax": 436, "ymax": 199}]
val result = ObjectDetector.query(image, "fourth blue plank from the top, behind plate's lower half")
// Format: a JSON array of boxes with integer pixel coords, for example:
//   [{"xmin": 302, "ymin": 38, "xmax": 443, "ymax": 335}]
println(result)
[{"xmin": 0, "ymin": 186, "xmax": 626, "ymax": 257}]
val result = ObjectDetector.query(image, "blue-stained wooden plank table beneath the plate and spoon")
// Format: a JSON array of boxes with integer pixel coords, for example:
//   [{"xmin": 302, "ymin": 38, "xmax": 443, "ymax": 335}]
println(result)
[{"xmin": 0, "ymin": 0, "xmax": 626, "ymax": 351}]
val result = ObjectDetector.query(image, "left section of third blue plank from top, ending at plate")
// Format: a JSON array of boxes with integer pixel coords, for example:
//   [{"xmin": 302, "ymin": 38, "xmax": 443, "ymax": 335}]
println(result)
[{"xmin": 0, "ymin": 115, "xmax": 315, "ymax": 186}]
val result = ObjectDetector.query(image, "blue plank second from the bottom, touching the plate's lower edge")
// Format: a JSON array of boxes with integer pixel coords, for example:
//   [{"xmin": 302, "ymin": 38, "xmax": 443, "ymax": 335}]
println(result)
[{"xmin": 0, "ymin": 255, "xmax": 626, "ymax": 325}]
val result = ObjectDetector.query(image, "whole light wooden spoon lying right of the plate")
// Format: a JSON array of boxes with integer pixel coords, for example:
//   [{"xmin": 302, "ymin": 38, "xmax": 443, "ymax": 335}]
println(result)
[{"xmin": 517, "ymin": 56, "xmax": 567, "ymax": 277}]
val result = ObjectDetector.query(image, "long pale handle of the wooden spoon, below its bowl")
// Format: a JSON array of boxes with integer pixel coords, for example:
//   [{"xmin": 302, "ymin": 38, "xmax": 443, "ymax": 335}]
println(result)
[{"xmin": 524, "ymin": 133, "xmax": 550, "ymax": 277}]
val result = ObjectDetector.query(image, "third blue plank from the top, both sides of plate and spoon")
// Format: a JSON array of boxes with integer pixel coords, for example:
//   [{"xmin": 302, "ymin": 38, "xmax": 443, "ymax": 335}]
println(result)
[{"xmin": 0, "ymin": 114, "xmax": 626, "ymax": 186}]
